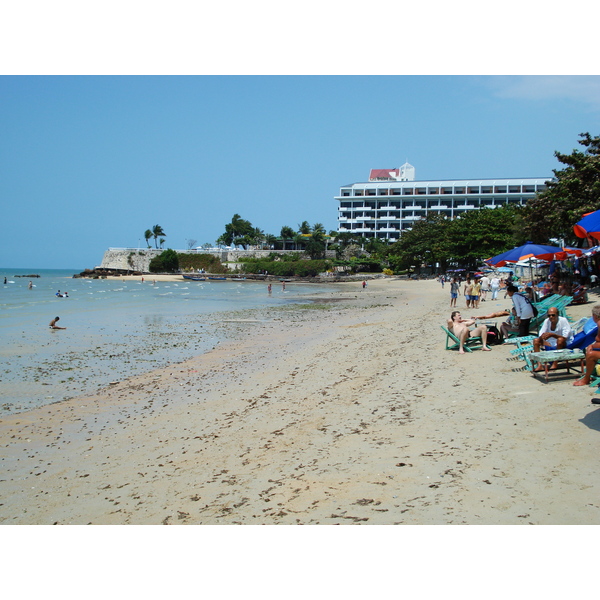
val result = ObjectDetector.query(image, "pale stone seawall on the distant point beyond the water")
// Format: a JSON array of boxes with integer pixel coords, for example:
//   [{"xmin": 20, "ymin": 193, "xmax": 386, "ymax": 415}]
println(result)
[{"xmin": 97, "ymin": 248, "xmax": 335, "ymax": 273}]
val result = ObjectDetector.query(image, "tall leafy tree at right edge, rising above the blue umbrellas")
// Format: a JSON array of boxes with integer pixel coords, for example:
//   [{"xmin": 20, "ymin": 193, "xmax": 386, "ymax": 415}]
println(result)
[{"xmin": 523, "ymin": 133, "xmax": 600, "ymax": 244}]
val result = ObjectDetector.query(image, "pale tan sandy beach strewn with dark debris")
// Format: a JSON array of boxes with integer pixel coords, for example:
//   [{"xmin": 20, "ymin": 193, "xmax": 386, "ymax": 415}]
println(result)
[{"xmin": 0, "ymin": 279, "xmax": 600, "ymax": 525}]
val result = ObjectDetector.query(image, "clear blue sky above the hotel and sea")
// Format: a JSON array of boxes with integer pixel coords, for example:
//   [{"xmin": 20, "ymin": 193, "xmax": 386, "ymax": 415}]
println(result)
[{"xmin": 0, "ymin": 75, "xmax": 600, "ymax": 270}]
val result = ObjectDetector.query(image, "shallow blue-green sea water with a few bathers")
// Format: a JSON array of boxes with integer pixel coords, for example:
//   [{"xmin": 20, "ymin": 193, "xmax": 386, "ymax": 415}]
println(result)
[{"xmin": 0, "ymin": 269, "xmax": 331, "ymax": 418}]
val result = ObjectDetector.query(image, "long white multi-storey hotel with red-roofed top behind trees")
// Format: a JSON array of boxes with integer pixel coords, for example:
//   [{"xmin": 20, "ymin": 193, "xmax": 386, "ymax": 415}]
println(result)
[{"xmin": 335, "ymin": 163, "xmax": 551, "ymax": 241}]
